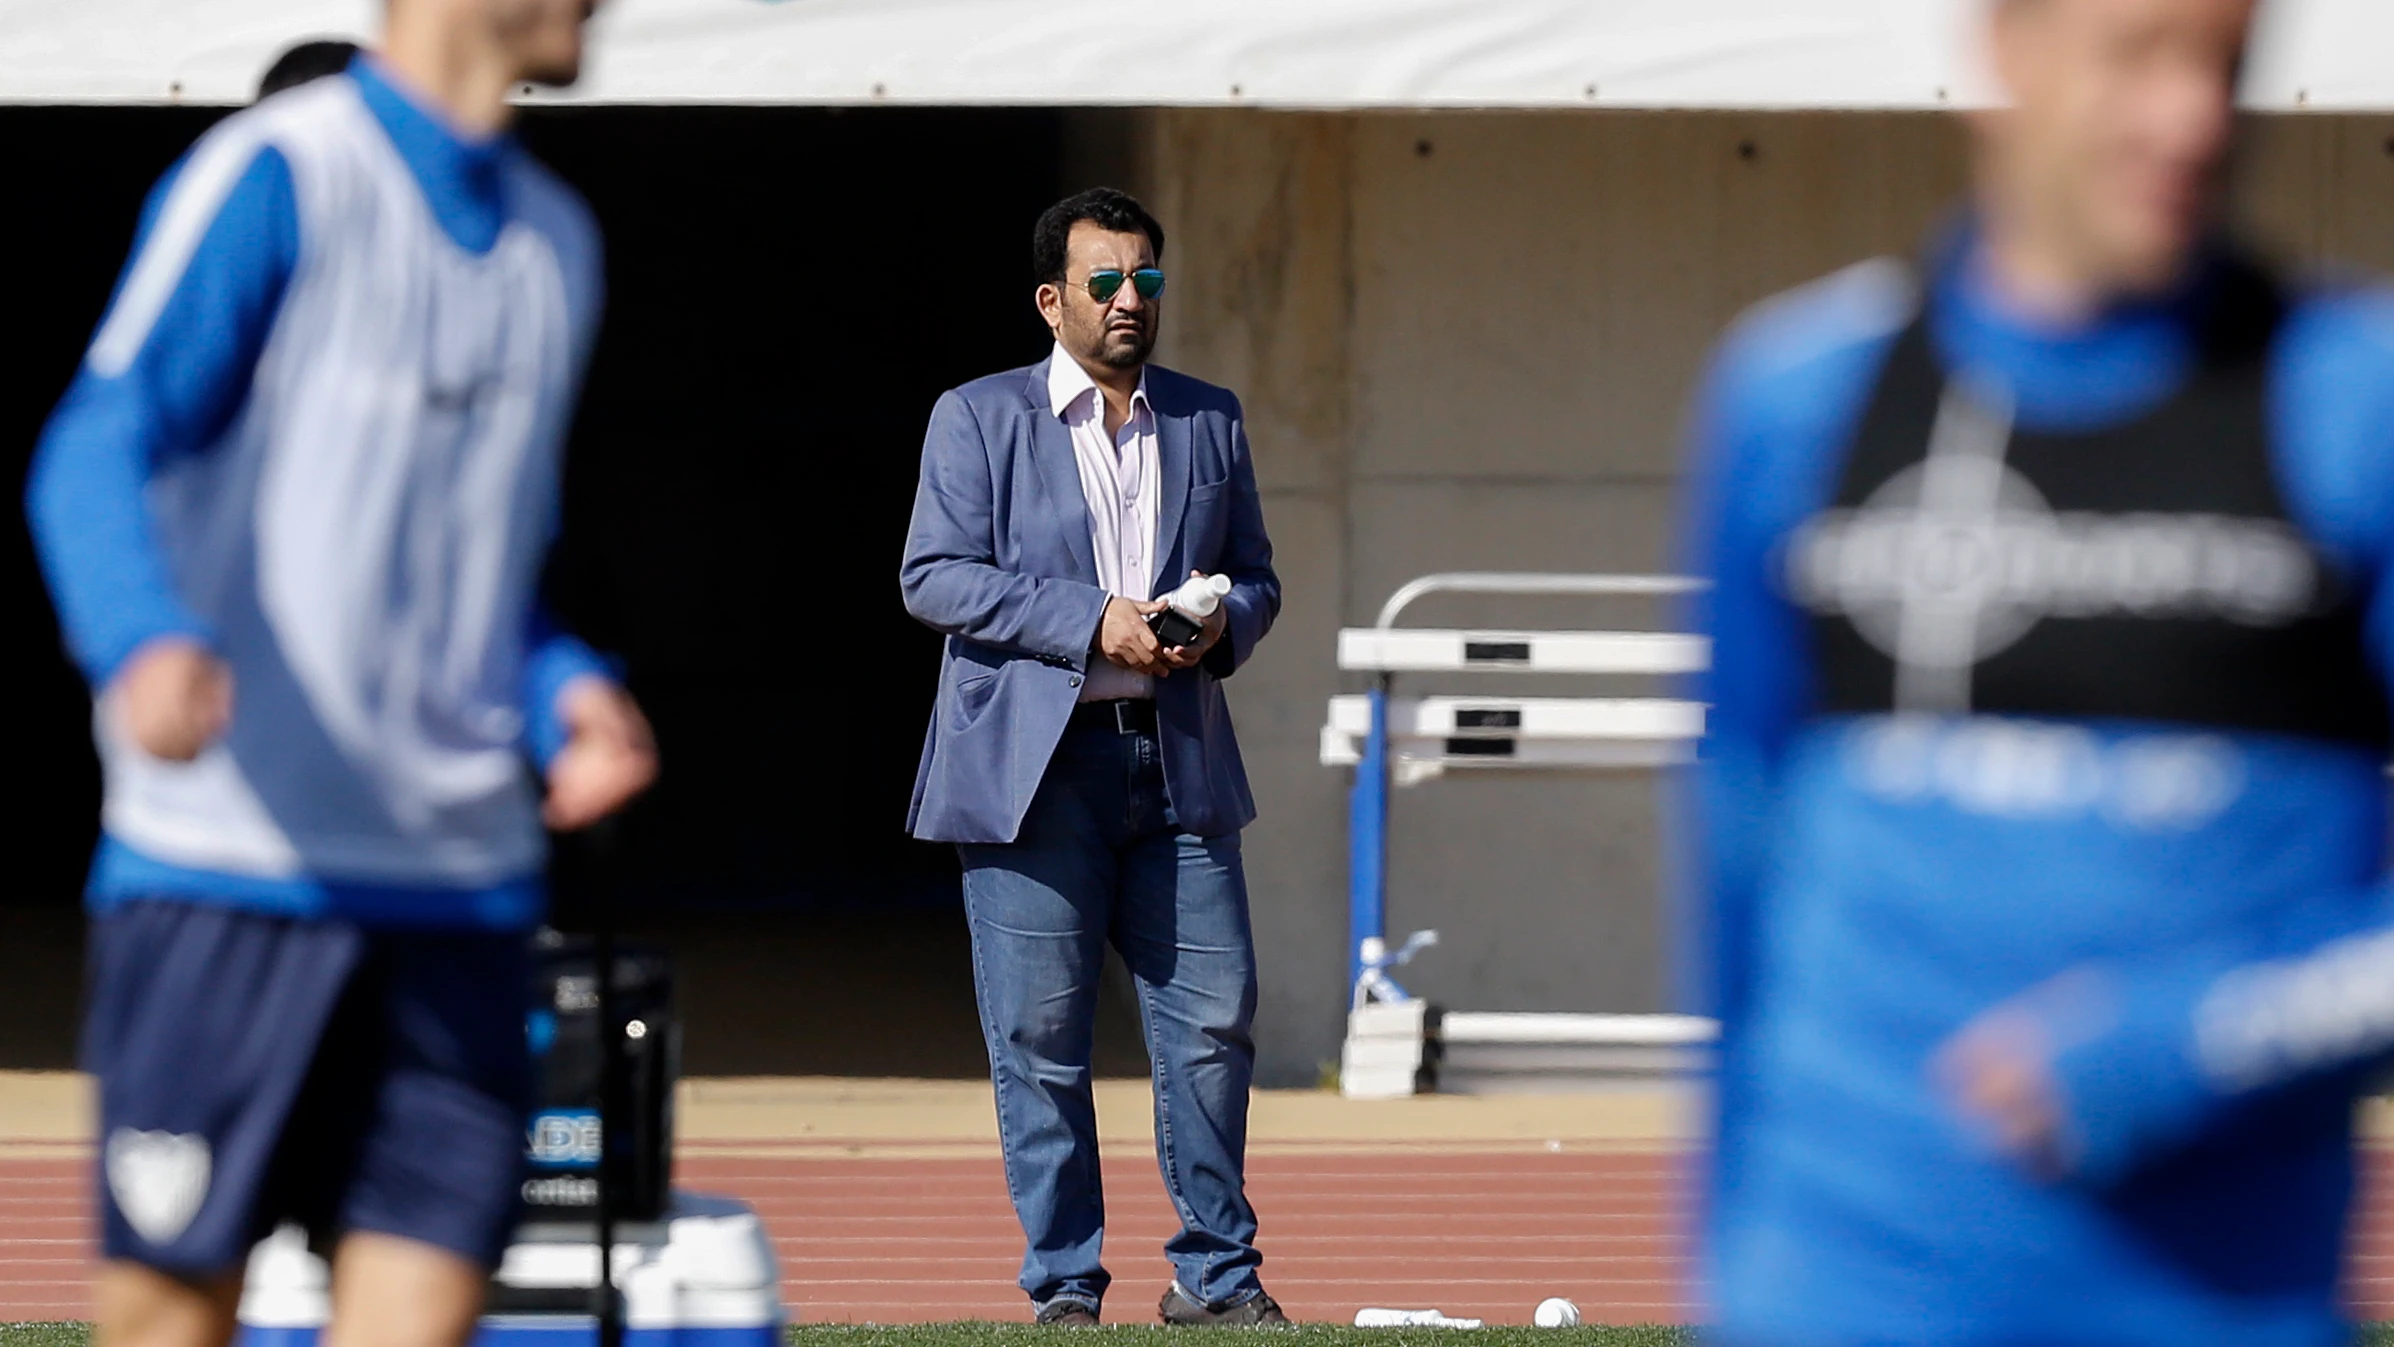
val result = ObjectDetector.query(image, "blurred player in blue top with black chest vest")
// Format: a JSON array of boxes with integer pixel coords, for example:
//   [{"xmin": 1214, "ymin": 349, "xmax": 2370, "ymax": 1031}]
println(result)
[{"xmin": 1693, "ymin": 0, "xmax": 2394, "ymax": 1347}]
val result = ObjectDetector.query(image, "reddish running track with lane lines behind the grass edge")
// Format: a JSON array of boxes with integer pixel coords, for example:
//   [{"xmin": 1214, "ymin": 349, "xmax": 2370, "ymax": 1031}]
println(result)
[{"xmin": 0, "ymin": 1146, "xmax": 2394, "ymax": 1323}]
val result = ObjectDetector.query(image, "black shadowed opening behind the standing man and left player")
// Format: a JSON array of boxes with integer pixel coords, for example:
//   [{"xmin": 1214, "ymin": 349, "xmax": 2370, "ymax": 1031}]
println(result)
[{"xmin": 0, "ymin": 108, "xmax": 1163, "ymax": 1077}]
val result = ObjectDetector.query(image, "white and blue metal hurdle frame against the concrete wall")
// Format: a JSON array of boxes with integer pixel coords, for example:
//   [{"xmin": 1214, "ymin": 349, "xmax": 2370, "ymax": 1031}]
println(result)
[{"xmin": 1321, "ymin": 572, "xmax": 1714, "ymax": 1098}]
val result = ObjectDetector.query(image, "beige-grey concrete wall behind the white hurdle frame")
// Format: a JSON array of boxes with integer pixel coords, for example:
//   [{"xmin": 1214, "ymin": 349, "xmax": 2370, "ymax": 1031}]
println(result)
[{"xmin": 1068, "ymin": 110, "xmax": 2394, "ymax": 1084}]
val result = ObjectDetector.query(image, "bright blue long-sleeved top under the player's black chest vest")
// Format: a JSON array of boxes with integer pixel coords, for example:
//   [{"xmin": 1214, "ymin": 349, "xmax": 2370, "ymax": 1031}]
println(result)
[{"xmin": 1681, "ymin": 234, "xmax": 2394, "ymax": 1347}]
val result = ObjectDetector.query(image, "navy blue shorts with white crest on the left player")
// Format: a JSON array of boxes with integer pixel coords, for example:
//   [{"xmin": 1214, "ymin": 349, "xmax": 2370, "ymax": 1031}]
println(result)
[{"xmin": 84, "ymin": 900, "xmax": 531, "ymax": 1278}]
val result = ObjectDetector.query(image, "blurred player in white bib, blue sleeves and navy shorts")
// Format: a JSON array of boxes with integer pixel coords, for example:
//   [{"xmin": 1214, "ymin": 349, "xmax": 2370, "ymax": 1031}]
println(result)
[{"xmin": 29, "ymin": 0, "xmax": 654, "ymax": 1347}]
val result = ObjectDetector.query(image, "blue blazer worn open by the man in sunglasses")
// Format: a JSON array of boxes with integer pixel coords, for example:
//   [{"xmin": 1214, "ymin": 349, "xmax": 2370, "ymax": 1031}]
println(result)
[{"xmin": 898, "ymin": 361, "xmax": 1281, "ymax": 842}]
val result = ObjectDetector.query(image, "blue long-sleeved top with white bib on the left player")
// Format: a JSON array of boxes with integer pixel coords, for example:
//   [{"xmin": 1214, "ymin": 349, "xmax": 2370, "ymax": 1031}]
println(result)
[{"xmin": 26, "ymin": 57, "xmax": 608, "ymax": 928}]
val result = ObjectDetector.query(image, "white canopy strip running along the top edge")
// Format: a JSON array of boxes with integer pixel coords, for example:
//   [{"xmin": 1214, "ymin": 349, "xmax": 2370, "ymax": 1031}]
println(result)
[{"xmin": 0, "ymin": 0, "xmax": 2394, "ymax": 112}]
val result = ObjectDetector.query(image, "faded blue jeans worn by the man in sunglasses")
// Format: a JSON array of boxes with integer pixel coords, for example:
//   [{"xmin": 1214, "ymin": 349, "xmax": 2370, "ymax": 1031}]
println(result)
[{"xmin": 958, "ymin": 725, "xmax": 1264, "ymax": 1309}]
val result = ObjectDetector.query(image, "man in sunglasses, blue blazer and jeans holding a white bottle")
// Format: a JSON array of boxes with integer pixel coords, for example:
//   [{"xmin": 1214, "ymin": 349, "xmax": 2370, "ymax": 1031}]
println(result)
[{"xmin": 900, "ymin": 189, "xmax": 1286, "ymax": 1325}]
